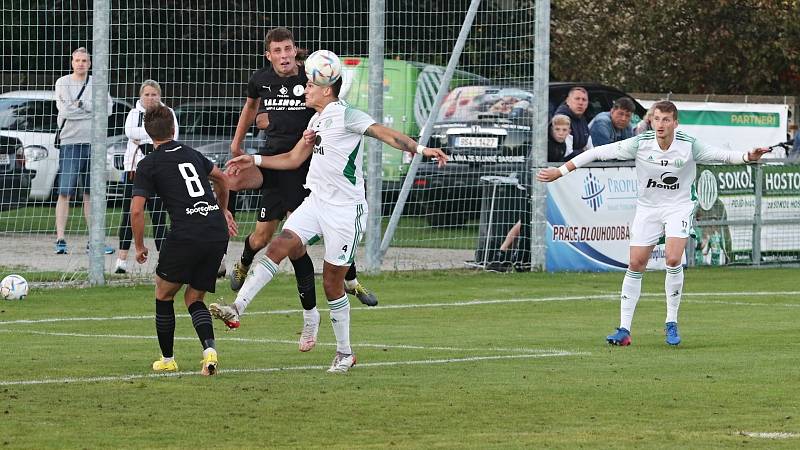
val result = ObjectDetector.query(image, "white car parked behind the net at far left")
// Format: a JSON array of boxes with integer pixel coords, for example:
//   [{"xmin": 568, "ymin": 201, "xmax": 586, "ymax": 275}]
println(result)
[{"xmin": 0, "ymin": 91, "xmax": 133, "ymax": 200}]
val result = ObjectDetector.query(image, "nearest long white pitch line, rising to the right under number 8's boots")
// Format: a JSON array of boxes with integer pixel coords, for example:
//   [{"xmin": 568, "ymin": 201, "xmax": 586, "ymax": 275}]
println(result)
[{"xmin": 0, "ymin": 352, "xmax": 585, "ymax": 386}]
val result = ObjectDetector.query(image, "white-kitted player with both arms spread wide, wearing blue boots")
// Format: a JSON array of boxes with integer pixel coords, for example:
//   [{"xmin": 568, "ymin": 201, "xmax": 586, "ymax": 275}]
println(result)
[{"xmin": 536, "ymin": 101, "xmax": 769, "ymax": 346}]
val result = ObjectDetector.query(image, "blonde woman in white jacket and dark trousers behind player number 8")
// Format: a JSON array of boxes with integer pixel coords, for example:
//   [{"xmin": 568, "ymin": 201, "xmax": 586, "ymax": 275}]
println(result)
[{"xmin": 114, "ymin": 80, "xmax": 178, "ymax": 273}]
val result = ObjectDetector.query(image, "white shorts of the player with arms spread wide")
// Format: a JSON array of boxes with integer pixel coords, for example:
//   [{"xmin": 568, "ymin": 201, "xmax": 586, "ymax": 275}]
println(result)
[{"xmin": 630, "ymin": 204, "xmax": 695, "ymax": 247}]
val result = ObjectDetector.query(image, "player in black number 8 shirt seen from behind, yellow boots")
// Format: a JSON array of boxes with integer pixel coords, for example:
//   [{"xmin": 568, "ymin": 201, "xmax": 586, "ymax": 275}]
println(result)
[{"xmin": 131, "ymin": 105, "xmax": 236, "ymax": 375}]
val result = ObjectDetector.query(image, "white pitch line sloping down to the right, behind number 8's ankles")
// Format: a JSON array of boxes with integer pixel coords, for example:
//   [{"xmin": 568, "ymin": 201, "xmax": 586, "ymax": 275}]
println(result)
[{"xmin": 0, "ymin": 329, "xmax": 567, "ymax": 354}]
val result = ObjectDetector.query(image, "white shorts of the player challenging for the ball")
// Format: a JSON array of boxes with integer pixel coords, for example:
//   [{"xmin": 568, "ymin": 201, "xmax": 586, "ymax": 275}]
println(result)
[{"xmin": 283, "ymin": 192, "xmax": 367, "ymax": 266}]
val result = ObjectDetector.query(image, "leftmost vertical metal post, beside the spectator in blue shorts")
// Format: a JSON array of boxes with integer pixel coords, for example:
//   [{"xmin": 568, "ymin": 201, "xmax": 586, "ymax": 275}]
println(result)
[{"xmin": 87, "ymin": 0, "xmax": 110, "ymax": 285}]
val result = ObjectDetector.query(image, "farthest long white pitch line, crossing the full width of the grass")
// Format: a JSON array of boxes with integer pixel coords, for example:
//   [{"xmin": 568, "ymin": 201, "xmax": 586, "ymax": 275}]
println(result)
[{"xmin": 0, "ymin": 291, "xmax": 800, "ymax": 326}]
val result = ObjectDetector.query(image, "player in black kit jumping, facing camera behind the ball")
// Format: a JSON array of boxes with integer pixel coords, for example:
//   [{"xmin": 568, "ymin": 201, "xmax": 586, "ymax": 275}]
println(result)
[{"xmin": 210, "ymin": 27, "xmax": 378, "ymax": 342}]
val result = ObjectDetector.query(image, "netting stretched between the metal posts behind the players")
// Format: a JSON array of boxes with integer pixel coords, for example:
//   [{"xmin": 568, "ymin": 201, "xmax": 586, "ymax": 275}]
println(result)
[{"xmin": 0, "ymin": 0, "xmax": 535, "ymax": 280}]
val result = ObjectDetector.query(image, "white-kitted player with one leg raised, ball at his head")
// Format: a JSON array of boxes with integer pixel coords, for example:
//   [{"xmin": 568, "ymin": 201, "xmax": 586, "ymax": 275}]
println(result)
[{"xmin": 226, "ymin": 62, "xmax": 447, "ymax": 373}]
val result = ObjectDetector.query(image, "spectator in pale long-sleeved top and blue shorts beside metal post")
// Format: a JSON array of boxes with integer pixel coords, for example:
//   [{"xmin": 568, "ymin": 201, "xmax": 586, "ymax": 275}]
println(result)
[{"xmin": 55, "ymin": 47, "xmax": 114, "ymax": 255}]
